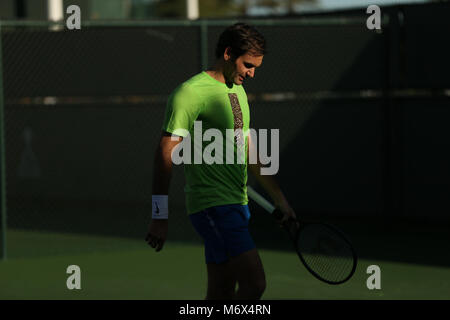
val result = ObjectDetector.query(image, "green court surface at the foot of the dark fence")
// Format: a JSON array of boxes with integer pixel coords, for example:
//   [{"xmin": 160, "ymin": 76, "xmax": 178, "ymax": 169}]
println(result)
[{"xmin": 0, "ymin": 230, "xmax": 450, "ymax": 300}]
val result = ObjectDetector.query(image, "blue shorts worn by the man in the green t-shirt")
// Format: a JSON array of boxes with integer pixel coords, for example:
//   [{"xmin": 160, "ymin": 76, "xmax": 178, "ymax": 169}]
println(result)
[{"xmin": 189, "ymin": 204, "xmax": 255, "ymax": 264}]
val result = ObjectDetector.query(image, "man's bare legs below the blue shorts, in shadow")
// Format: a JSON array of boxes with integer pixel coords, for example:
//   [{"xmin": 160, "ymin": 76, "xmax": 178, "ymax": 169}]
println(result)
[{"xmin": 206, "ymin": 249, "xmax": 266, "ymax": 300}]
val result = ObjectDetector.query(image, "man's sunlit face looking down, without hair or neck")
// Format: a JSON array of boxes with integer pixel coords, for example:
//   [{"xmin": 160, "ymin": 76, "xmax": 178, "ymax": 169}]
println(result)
[{"xmin": 225, "ymin": 52, "xmax": 264, "ymax": 85}]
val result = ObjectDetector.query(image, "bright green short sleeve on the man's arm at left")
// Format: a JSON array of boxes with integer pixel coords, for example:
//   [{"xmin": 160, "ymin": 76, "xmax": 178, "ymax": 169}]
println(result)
[{"xmin": 162, "ymin": 83, "xmax": 202, "ymax": 137}]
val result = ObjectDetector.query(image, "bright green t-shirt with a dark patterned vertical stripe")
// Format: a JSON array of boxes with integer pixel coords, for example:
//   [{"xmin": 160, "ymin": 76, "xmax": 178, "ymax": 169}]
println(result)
[{"xmin": 162, "ymin": 71, "xmax": 250, "ymax": 214}]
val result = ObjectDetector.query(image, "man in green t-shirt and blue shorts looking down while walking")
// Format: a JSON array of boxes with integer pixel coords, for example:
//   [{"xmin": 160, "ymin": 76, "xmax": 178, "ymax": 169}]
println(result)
[{"xmin": 146, "ymin": 23, "xmax": 295, "ymax": 300}]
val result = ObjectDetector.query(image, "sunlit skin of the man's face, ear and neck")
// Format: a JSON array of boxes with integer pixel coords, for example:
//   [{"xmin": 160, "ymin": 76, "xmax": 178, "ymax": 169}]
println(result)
[{"xmin": 206, "ymin": 48, "xmax": 264, "ymax": 87}]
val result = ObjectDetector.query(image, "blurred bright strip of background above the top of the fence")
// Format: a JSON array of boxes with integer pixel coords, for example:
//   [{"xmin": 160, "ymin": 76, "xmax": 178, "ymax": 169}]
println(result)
[{"xmin": 0, "ymin": 0, "xmax": 445, "ymax": 20}]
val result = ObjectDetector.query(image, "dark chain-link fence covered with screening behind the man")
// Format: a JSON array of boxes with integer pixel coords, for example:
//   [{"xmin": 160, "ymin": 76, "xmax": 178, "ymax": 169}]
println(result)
[{"xmin": 0, "ymin": 2, "xmax": 450, "ymax": 258}]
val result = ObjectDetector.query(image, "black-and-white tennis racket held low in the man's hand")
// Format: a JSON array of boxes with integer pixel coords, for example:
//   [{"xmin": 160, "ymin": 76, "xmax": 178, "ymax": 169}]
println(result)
[{"xmin": 247, "ymin": 186, "xmax": 357, "ymax": 284}]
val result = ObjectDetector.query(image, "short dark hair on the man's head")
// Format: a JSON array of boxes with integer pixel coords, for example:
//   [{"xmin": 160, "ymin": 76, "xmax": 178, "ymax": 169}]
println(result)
[{"xmin": 216, "ymin": 22, "xmax": 267, "ymax": 58}]
